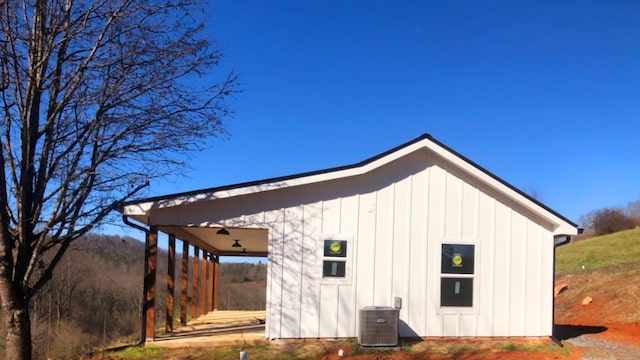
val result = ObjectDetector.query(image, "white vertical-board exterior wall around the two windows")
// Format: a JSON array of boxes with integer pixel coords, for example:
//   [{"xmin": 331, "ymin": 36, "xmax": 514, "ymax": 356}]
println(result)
[{"xmin": 153, "ymin": 150, "xmax": 554, "ymax": 338}]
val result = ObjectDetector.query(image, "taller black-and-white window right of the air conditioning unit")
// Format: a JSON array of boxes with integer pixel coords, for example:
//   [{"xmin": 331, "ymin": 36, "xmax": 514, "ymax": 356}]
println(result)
[{"xmin": 440, "ymin": 244, "xmax": 475, "ymax": 307}]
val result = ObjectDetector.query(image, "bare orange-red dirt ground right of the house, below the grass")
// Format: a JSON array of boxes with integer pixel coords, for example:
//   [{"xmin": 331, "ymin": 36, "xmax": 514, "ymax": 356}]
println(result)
[{"xmin": 555, "ymin": 264, "xmax": 640, "ymax": 359}]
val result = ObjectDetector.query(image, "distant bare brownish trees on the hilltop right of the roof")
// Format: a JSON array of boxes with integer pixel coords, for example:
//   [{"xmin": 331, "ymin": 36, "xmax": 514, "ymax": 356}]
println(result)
[{"xmin": 580, "ymin": 200, "xmax": 640, "ymax": 238}]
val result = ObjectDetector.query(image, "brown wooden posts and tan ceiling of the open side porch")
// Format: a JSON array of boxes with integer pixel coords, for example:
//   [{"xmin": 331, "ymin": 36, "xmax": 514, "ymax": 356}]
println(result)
[{"xmin": 122, "ymin": 205, "xmax": 268, "ymax": 342}]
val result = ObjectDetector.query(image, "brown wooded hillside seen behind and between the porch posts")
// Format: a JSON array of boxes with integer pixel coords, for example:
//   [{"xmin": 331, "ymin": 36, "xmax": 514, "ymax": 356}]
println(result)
[{"xmin": 0, "ymin": 234, "xmax": 267, "ymax": 359}]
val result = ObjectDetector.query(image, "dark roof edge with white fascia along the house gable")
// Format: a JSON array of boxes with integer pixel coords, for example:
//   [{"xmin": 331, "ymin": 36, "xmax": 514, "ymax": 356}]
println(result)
[{"xmin": 123, "ymin": 133, "xmax": 578, "ymax": 228}]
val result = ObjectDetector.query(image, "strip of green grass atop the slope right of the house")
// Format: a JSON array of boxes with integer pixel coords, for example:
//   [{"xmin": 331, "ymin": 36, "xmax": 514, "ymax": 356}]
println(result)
[{"xmin": 556, "ymin": 228, "xmax": 640, "ymax": 275}]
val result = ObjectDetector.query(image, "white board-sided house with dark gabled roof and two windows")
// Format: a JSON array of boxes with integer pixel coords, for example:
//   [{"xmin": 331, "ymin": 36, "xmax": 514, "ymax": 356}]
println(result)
[{"xmin": 122, "ymin": 135, "xmax": 577, "ymax": 339}]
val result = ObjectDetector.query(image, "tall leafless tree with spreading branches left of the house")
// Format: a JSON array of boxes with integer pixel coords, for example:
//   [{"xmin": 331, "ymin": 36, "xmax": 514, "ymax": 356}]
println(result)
[{"xmin": 0, "ymin": 0, "xmax": 237, "ymax": 359}]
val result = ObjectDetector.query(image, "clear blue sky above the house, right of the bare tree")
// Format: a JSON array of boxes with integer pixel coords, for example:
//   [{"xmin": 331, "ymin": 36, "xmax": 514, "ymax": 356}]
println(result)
[{"xmin": 117, "ymin": 0, "xmax": 640, "ymax": 239}]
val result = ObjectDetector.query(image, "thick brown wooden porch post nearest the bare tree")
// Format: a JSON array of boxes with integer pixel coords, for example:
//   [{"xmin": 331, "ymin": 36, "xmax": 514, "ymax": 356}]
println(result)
[{"xmin": 144, "ymin": 225, "xmax": 158, "ymax": 341}]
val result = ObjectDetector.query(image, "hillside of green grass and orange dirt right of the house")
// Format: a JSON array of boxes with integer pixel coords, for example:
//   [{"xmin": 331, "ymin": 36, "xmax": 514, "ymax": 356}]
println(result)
[{"xmin": 555, "ymin": 228, "xmax": 640, "ymax": 325}]
